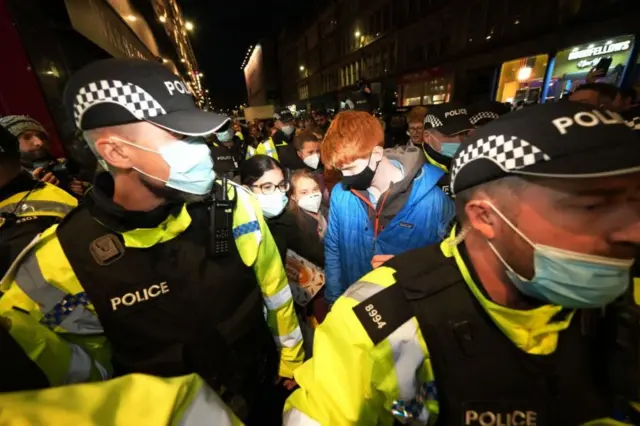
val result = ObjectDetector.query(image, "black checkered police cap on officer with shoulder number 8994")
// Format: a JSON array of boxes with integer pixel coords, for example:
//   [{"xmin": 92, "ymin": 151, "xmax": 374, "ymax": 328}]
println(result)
[{"xmin": 451, "ymin": 102, "xmax": 640, "ymax": 194}]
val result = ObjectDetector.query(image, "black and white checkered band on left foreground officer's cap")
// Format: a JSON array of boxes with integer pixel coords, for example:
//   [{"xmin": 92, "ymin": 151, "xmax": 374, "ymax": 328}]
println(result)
[{"xmin": 73, "ymin": 80, "xmax": 166, "ymax": 127}]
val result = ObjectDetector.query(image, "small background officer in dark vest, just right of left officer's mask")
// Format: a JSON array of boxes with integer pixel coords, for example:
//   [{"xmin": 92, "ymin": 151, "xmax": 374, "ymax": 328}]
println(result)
[{"xmin": 211, "ymin": 121, "xmax": 246, "ymax": 179}]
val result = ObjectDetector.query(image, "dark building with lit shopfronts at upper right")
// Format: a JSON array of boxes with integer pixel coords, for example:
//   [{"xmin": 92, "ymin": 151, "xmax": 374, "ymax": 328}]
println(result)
[{"xmin": 278, "ymin": 0, "xmax": 640, "ymax": 111}]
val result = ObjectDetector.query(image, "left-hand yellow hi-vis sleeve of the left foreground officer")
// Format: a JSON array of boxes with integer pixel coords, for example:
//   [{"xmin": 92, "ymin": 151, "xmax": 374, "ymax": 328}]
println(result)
[{"xmin": 0, "ymin": 226, "xmax": 111, "ymax": 386}]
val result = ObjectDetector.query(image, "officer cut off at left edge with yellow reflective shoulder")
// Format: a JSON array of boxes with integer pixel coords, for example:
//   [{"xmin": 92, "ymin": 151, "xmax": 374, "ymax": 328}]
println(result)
[{"xmin": 0, "ymin": 126, "xmax": 78, "ymax": 275}]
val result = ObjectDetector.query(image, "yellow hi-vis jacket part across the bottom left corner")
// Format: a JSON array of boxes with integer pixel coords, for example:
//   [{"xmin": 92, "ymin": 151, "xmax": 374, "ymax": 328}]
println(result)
[{"xmin": 0, "ymin": 374, "xmax": 243, "ymax": 426}]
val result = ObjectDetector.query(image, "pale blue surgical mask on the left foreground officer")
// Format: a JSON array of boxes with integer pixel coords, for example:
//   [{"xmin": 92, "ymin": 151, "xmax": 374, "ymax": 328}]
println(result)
[{"xmin": 113, "ymin": 138, "xmax": 216, "ymax": 195}]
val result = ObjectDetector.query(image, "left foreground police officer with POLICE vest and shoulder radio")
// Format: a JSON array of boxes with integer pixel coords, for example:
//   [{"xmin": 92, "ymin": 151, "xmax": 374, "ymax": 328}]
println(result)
[{"xmin": 0, "ymin": 59, "xmax": 304, "ymax": 424}]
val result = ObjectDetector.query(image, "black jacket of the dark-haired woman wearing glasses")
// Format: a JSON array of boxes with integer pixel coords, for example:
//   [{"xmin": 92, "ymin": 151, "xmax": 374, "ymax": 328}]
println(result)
[{"xmin": 267, "ymin": 210, "xmax": 324, "ymax": 268}]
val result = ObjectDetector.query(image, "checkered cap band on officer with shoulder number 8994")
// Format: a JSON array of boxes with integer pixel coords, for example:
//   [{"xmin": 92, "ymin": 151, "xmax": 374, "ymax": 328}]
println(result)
[{"xmin": 451, "ymin": 135, "xmax": 551, "ymax": 191}]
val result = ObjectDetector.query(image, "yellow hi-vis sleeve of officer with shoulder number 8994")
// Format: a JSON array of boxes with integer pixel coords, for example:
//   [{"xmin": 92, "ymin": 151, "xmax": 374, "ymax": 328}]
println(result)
[{"xmin": 284, "ymin": 267, "xmax": 438, "ymax": 426}]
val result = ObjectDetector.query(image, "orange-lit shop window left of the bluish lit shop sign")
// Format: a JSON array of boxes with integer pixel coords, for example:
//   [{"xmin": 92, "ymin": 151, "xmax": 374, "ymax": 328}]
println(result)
[{"xmin": 496, "ymin": 55, "xmax": 549, "ymax": 103}]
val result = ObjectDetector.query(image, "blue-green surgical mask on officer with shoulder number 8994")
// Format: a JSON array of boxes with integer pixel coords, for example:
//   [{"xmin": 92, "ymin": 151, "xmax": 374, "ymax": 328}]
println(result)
[{"xmin": 488, "ymin": 203, "xmax": 634, "ymax": 309}]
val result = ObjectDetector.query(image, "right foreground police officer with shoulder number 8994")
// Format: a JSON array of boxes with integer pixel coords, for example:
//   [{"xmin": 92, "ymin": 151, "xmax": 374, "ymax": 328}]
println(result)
[{"xmin": 285, "ymin": 103, "xmax": 640, "ymax": 426}]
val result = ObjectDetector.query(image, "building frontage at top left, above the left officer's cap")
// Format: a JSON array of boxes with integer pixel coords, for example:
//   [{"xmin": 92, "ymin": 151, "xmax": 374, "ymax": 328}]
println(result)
[{"xmin": 0, "ymin": 0, "xmax": 202, "ymax": 155}]
